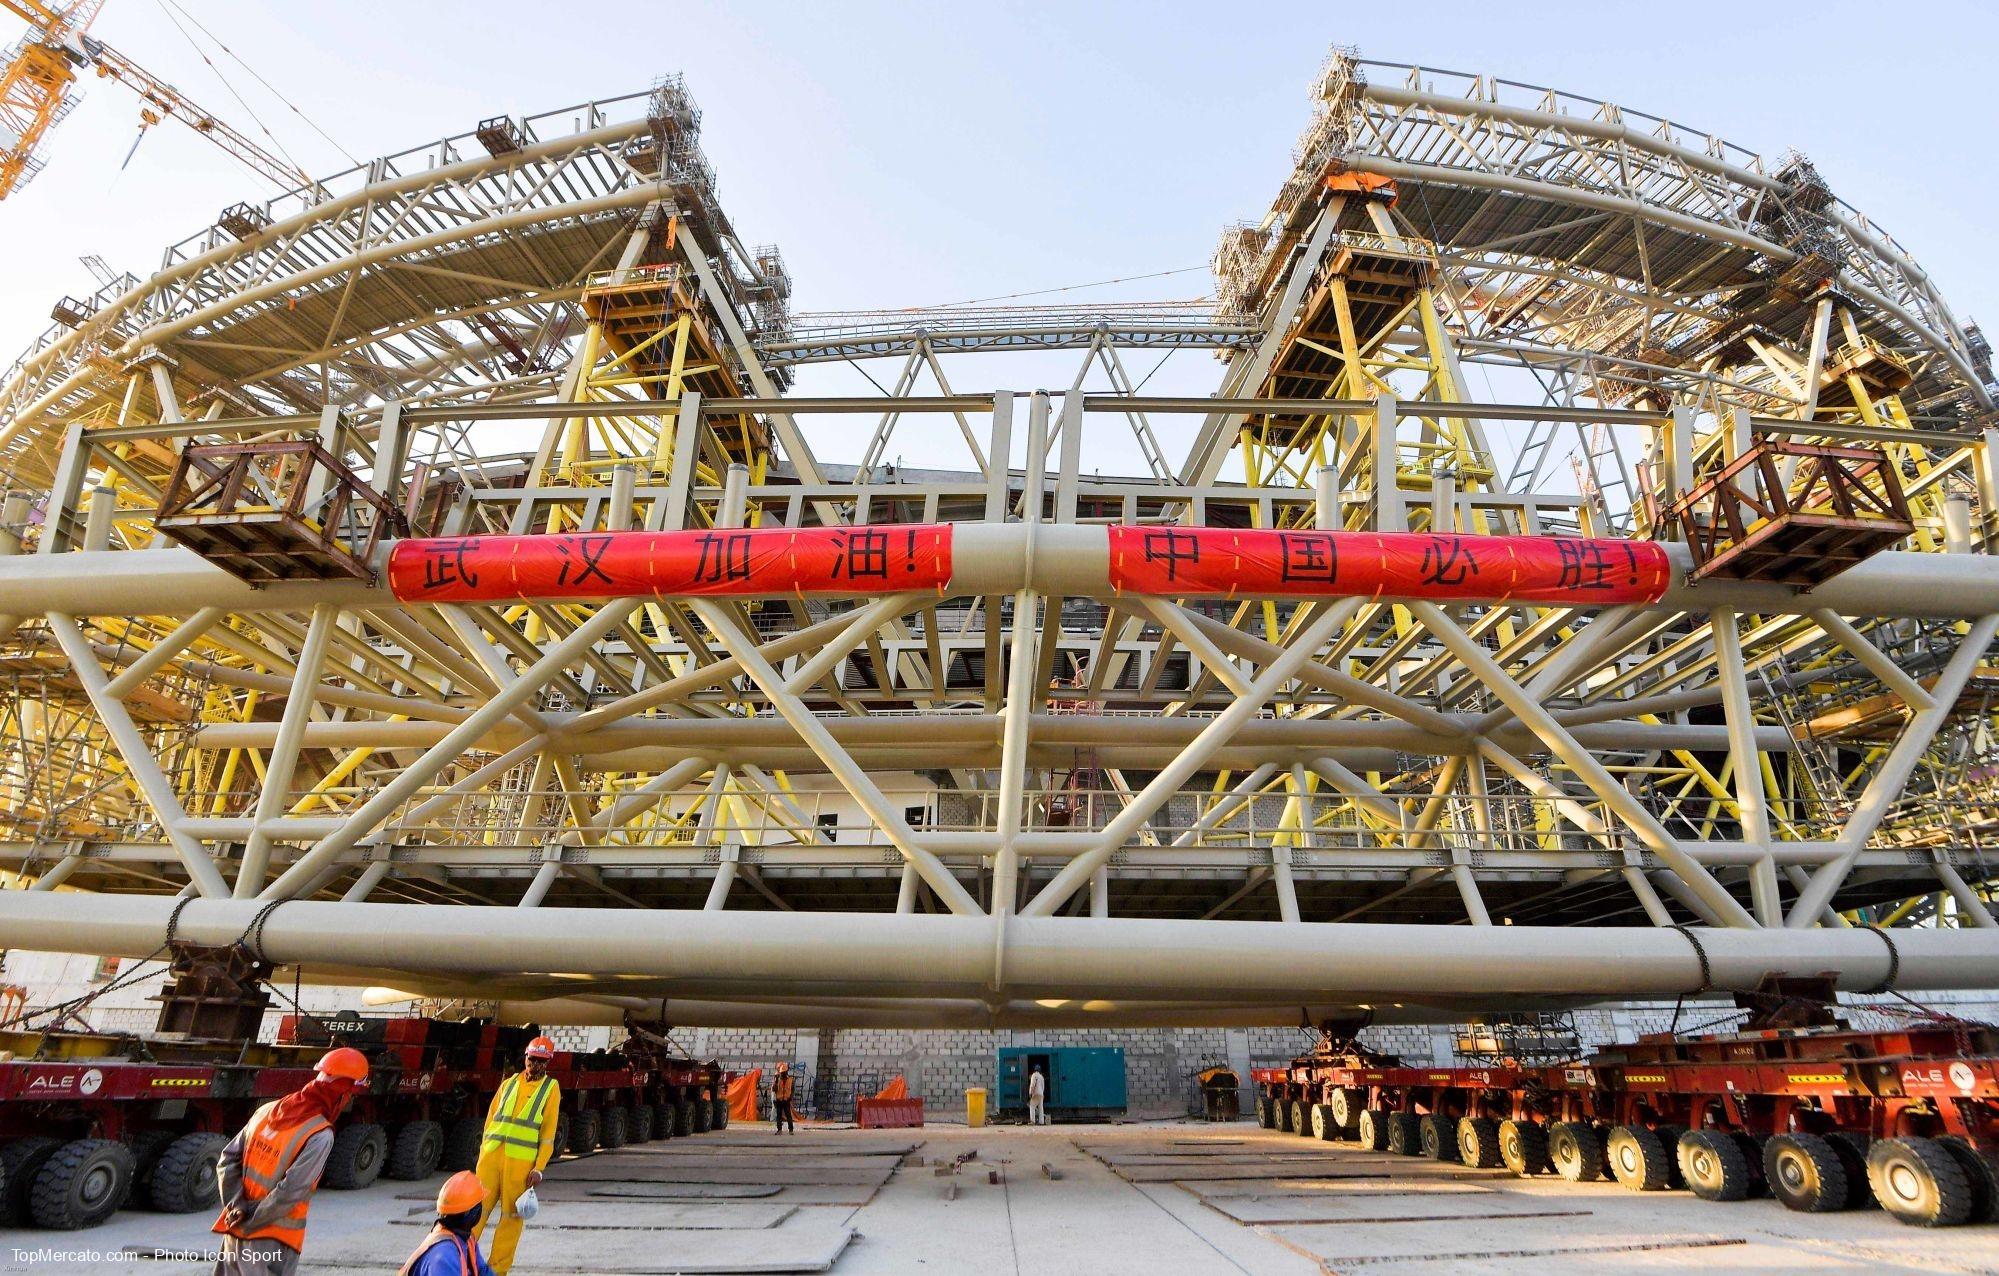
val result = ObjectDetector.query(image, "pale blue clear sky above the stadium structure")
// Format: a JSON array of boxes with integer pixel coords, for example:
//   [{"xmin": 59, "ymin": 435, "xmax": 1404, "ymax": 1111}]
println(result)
[{"xmin": 0, "ymin": 0, "xmax": 1999, "ymax": 470}]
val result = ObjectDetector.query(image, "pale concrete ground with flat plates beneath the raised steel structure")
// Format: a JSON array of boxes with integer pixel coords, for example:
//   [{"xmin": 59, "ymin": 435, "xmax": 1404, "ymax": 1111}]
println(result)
[{"xmin": 0, "ymin": 1122, "xmax": 1999, "ymax": 1276}]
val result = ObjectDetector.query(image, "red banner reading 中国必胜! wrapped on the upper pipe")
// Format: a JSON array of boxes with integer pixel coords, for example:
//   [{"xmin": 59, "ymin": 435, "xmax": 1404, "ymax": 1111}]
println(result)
[{"xmin": 1109, "ymin": 526, "xmax": 1671, "ymax": 606}]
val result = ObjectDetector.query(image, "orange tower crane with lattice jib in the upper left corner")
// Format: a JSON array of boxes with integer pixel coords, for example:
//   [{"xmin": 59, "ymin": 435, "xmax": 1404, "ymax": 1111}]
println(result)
[{"xmin": 0, "ymin": 0, "xmax": 312, "ymax": 200}]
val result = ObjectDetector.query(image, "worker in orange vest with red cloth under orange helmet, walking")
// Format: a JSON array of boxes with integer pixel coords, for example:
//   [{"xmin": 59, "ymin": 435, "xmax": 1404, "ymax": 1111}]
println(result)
[{"xmin": 214, "ymin": 1046, "xmax": 368, "ymax": 1276}]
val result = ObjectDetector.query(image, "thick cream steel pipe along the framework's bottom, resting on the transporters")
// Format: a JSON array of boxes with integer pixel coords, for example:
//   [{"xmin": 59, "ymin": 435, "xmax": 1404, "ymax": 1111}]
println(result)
[{"xmin": 0, "ymin": 890, "xmax": 1999, "ymax": 1004}]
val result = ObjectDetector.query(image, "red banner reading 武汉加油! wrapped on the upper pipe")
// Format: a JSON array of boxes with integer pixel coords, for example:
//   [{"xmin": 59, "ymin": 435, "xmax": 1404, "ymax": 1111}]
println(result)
[{"xmin": 388, "ymin": 524, "xmax": 952, "ymax": 602}]
